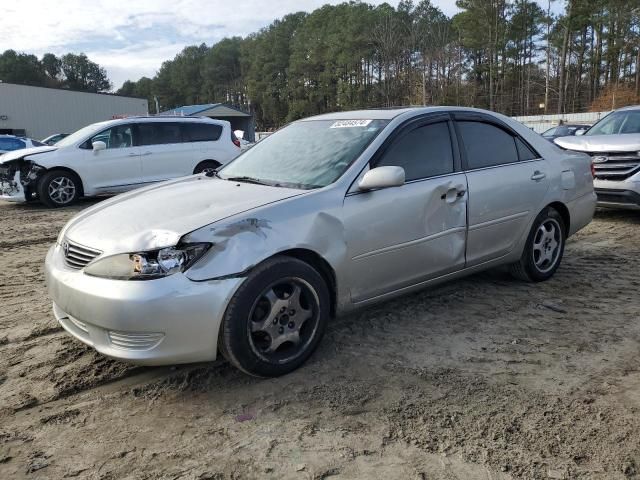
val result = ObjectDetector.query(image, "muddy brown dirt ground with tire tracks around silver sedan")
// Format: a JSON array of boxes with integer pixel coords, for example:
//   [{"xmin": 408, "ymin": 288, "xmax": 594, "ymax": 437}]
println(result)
[{"xmin": 0, "ymin": 202, "xmax": 640, "ymax": 480}]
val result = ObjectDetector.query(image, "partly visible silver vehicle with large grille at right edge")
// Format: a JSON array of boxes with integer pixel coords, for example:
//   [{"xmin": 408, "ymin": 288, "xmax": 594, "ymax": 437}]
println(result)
[{"xmin": 554, "ymin": 106, "xmax": 640, "ymax": 210}]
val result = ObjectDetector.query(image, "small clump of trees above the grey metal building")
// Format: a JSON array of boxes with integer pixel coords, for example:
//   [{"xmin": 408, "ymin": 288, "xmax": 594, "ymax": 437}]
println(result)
[{"xmin": 0, "ymin": 50, "xmax": 112, "ymax": 93}]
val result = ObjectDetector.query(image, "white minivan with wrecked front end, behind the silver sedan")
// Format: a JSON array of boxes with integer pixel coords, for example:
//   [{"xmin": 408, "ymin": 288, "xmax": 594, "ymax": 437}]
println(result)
[{"xmin": 0, "ymin": 117, "xmax": 241, "ymax": 207}]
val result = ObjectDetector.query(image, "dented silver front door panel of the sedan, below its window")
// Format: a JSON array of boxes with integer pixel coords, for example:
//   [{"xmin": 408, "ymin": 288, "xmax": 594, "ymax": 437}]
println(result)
[{"xmin": 344, "ymin": 173, "xmax": 467, "ymax": 302}]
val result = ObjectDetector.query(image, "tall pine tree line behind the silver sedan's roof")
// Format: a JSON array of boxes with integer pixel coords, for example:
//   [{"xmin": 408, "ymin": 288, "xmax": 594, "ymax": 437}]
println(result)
[{"xmin": 119, "ymin": 0, "xmax": 640, "ymax": 129}]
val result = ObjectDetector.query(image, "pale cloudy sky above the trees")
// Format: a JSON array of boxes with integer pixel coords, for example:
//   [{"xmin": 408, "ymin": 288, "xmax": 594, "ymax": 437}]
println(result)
[{"xmin": 0, "ymin": 0, "xmax": 556, "ymax": 89}]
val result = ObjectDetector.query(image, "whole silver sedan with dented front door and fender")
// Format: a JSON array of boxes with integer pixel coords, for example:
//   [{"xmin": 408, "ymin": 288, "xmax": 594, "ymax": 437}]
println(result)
[{"xmin": 46, "ymin": 107, "xmax": 596, "ymax": 376}]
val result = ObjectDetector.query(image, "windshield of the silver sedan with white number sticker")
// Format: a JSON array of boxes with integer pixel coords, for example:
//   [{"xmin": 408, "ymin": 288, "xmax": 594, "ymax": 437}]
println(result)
[{"xmin": 219, "ymin": 120, "xmax": 388, "ymax": 189}]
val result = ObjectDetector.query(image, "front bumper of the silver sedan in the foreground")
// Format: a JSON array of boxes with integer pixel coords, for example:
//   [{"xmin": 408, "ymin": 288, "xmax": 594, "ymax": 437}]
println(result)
[{"xmin": 45, "ymin": 245, "xmax": 243, "ymax": 365}]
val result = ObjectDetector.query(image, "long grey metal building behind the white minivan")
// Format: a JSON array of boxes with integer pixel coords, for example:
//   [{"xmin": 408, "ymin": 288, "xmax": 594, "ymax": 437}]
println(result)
[{"xmin": 0, "ymin": 83, "xmax": 148, "ymax": 140}]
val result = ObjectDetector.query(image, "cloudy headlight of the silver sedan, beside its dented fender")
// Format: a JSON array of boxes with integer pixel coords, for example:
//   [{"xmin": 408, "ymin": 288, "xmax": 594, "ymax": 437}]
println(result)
[{"xmin": 84, "ymin": 243, "xmax": 211, "ymax": 280}]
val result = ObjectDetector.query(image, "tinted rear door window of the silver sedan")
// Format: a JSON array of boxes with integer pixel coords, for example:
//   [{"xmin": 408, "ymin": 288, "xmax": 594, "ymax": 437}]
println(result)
[{"xmin": 458, "ymin": 121, "xmax": 519, "ymax": 170}]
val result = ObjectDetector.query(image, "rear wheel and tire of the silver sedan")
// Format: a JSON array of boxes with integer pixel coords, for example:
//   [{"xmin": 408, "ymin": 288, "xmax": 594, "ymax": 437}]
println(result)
[{"xmin": 510, "ymin": 207, "xmax": 567, "ymax": 282}]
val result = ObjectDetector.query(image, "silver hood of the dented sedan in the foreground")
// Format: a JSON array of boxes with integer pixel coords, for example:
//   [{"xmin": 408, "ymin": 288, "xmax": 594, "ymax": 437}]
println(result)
[{"xmin": 61, "ymin": 175, "xmax": 304, "ymax": 254}]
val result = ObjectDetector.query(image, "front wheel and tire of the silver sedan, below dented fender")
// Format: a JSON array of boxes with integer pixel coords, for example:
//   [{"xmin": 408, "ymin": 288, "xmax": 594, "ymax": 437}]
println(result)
[{"xmin": 218, "ymin": 256, "xmax": 330, "ymax": 377}]
